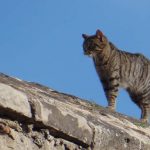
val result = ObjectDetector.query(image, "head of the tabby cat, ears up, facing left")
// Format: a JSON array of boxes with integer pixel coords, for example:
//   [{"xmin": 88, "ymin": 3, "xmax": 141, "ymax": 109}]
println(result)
[{"xmin": 82, "ymin": 30, "xmax": 108, "ymax": 56}]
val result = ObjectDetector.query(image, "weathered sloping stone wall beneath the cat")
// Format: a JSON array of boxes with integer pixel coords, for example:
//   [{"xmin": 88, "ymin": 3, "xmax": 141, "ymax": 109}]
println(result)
[{"xmin": 0, "ymin": 74, "xmax": 150, "ymax": 150}]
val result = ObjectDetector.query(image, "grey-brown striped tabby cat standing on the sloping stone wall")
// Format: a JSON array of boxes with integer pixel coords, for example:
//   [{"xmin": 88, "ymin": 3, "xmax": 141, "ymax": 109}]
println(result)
[{"xmin": 82, "ymin": 30, "xmax": 150, "ymax": 122}]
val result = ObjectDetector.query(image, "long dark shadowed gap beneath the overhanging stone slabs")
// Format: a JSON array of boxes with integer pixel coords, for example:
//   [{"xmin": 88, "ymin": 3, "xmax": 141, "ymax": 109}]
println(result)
[{"xmin": 0, "ymin": 103, "xmax": 89, "ymax": 148}]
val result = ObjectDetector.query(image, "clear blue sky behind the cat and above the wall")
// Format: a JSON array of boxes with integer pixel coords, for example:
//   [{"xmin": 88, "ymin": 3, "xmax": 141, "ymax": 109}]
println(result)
[{"xmin": 0, "ymin": 0, "xmax": 150, "ymax": 118}]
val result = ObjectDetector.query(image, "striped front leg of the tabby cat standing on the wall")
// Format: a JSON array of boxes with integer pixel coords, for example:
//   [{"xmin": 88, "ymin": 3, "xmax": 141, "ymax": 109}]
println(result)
[{"xmin": 103, "ymin": 76, "xmax": 119, "ymax": 110}]
